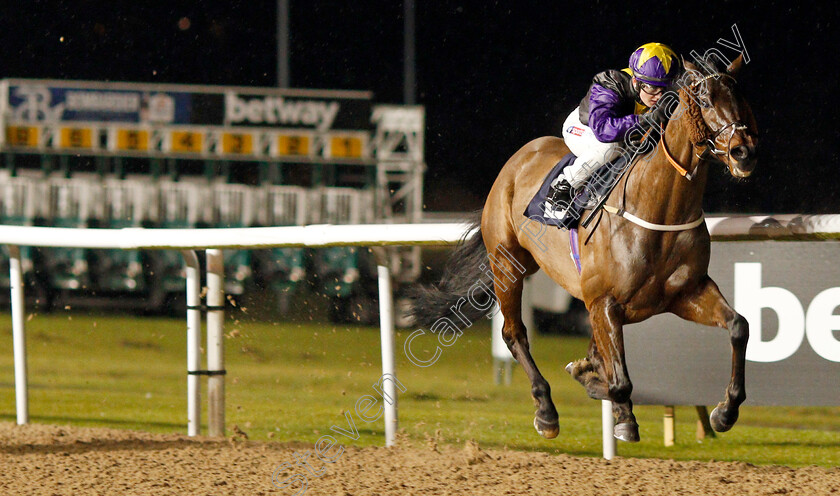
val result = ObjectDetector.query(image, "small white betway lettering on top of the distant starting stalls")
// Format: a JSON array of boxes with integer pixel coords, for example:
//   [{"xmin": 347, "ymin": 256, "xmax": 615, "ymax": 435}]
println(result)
[{"xmin": 225, "ymin": 93, "xmax": 340, "ymax": 131}]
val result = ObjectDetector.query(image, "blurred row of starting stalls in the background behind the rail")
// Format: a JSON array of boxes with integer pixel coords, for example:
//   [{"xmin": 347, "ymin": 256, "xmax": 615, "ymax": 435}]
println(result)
[{"xmin": 0, "ymin": 79, "xmax": 424, "ymax": 321}]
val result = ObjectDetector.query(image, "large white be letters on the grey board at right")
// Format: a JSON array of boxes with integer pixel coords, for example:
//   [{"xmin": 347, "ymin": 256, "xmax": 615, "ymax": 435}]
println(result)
[{"xmin": 734, "ymin": 263, "xmax": 840, "ymax": 362}]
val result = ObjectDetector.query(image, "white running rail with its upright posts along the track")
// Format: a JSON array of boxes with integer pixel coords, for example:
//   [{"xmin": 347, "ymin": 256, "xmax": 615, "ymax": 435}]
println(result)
[{"xmin": 0, "ymin": 214, "xmax": 840, "ymax": 459}]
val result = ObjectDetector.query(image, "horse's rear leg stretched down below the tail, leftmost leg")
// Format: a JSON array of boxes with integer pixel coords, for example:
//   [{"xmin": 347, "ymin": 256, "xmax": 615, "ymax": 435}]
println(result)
[{"xmin": 492, "ymin": 244, "xmax": 560, "ymax": 439}]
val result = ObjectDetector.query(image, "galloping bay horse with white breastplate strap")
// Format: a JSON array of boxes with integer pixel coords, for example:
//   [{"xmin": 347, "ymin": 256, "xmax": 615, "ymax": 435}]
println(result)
[{"xmin": 414, "ymin": 56, "xmax": 758, "ymax": 442}]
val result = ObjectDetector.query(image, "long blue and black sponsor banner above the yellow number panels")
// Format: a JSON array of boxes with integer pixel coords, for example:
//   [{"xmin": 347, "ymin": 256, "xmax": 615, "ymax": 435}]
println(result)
[{"xmin": 0, "ymin": 79, "xmax": 372, "ymax": 133}]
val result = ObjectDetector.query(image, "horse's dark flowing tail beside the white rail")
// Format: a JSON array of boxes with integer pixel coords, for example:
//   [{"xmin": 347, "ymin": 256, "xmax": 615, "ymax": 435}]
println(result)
[{"xmin": 409, "ymin": 216, "xmax": 493, "ymax": 329}]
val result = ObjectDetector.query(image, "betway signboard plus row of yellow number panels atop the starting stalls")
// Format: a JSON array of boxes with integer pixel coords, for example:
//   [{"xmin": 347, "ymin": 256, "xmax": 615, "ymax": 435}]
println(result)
[{"xmin": 0, "ymin": 79, "xmax": 373, "ymax": 162}]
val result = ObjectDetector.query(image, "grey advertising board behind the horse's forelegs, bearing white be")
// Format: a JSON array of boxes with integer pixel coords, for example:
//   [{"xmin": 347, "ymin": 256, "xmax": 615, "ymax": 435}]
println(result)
[{"xmin": 624, "ymin": 241, "xmax": 840, "ymax": 405}]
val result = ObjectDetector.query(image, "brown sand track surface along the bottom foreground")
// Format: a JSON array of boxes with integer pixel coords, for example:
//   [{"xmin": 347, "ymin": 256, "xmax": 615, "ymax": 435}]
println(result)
[{"xmin": 0, "ymin": 422, "xmax": 840, "ymax": 496}]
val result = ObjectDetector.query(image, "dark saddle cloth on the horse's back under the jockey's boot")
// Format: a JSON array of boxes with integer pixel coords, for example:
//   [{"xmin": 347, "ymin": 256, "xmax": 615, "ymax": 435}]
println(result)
[{"xmin": 525, "ymin": 153, "xmax": 627, "ymax": 229}]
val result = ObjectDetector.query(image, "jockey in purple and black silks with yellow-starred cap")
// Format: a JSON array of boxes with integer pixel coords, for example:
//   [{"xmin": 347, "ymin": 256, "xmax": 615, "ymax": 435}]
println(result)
[{"xmin": 545, "ymin": 43, "xmax": 680, "ymax": 218}]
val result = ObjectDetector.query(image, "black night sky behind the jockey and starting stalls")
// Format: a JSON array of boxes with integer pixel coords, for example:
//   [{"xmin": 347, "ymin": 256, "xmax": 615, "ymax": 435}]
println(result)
[{"xmin": 0, "ymin": 0, "xmax": 840, "ymax": 213}]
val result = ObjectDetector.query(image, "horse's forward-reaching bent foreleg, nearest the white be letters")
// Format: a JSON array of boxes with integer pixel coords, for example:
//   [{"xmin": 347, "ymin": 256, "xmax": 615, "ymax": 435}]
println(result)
[{"xmin": 668, "ymin": 276, "xmax": 750, "ymax": 432}]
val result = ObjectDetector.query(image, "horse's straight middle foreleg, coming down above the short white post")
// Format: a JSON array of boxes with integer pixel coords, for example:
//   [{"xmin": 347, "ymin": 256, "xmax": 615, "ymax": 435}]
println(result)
[{"xmin": 580, "ymin": 296, "xmax": 639, "ymax": 442}]
